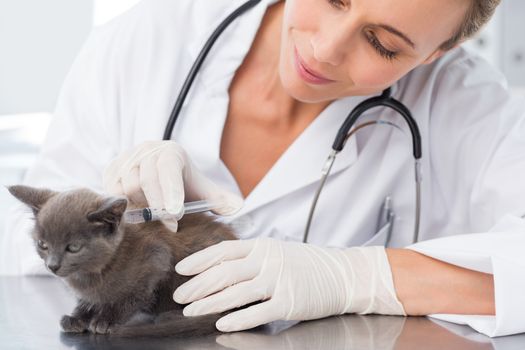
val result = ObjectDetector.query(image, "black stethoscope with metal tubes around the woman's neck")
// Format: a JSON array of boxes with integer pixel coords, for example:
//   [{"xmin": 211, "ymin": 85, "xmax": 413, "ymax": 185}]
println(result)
[{"xmin": 163, "ymin": 0, "xmax": 421, "ymax": 243}]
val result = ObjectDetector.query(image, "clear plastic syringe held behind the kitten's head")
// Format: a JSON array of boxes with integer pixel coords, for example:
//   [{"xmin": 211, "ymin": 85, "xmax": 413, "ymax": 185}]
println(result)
[{"xmin": 124, "ymin": 200, "xmax": 220, "ymax": 224}]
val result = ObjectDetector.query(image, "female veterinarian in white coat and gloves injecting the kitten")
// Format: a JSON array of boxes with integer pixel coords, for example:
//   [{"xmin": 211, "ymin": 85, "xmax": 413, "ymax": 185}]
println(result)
[{"xmin": 3, "ymin": 0, "xmax": 525, "ymax": 336}]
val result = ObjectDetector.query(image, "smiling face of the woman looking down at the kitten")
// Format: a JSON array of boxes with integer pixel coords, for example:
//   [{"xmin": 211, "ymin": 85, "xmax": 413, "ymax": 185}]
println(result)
[{"xmin": 279, "ymin": 0, "xmax": 470, "ymax": 103}]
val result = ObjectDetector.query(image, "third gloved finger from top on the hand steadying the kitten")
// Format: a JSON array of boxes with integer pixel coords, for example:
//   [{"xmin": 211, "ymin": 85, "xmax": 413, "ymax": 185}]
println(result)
[{"xmin": 183, "ymin": 280, "xmax": 271, "ymax": 316}]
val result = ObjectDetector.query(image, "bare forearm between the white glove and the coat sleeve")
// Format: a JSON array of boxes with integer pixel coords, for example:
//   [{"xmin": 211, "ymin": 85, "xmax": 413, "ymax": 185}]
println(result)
[{"xmin": 386, "ymin": 248, "xmax": 495, "ymax": 315}]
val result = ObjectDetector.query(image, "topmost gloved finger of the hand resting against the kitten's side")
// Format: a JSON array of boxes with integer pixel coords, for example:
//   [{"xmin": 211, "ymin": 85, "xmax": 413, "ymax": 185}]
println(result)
[{"xmin": 175, "ymin": 239, "xmax": 255, "ymax": 276}]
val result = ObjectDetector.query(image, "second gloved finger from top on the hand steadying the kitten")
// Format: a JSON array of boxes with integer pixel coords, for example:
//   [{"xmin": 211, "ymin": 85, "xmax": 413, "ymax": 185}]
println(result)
[{"xmin": 173, "ymin": 260, "xmax": 258, "ymax": 304}]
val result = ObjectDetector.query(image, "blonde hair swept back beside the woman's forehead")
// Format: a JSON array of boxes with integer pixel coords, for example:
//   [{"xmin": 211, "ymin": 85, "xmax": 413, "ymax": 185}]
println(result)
[{"xmin": 440, "ymin": 0, "xmax": 501, "ymax": 50}]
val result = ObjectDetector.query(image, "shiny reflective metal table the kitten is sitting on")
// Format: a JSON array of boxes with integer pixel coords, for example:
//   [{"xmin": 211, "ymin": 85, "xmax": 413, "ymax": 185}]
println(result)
[{"xmin": 0, "ymin": 276, "xmax": 525, "ymax": 350}]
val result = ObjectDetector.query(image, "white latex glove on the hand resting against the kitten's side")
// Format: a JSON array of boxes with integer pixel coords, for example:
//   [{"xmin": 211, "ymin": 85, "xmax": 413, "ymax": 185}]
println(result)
[{"xmin": 173, "ymin": 238, "xmax": 405, "ymax": 332}]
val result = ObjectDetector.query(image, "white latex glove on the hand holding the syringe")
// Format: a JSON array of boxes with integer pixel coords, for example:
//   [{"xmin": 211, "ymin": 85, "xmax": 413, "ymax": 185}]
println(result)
[{"xmin": 103, "ymin": 141, "xmax": 243, "ymax": 231}]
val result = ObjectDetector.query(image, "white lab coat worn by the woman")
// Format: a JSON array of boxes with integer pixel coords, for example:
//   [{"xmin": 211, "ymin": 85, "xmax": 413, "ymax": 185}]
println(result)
[{"xmin": 1, "ymin": 0, "xmax": 525, "ymax": 336}]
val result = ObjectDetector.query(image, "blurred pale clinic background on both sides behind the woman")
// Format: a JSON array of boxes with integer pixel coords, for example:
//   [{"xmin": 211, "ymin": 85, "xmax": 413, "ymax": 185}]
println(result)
[{"xmin": 0, "ymin": 0, "xmax": 525, "ymax": 241}]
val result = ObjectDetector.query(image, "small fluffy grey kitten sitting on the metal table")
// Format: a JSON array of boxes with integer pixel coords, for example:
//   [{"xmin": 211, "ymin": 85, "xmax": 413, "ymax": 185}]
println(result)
[{"xmin": 8, "ymin": 186, "xmax": 236, "ymax": 336}]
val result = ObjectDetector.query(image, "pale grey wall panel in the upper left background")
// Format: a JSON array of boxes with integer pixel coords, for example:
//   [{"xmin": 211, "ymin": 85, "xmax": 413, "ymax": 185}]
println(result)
[{"xmin": 0, "ymin": 0, "xmax": 93, "ymax": 115}]
